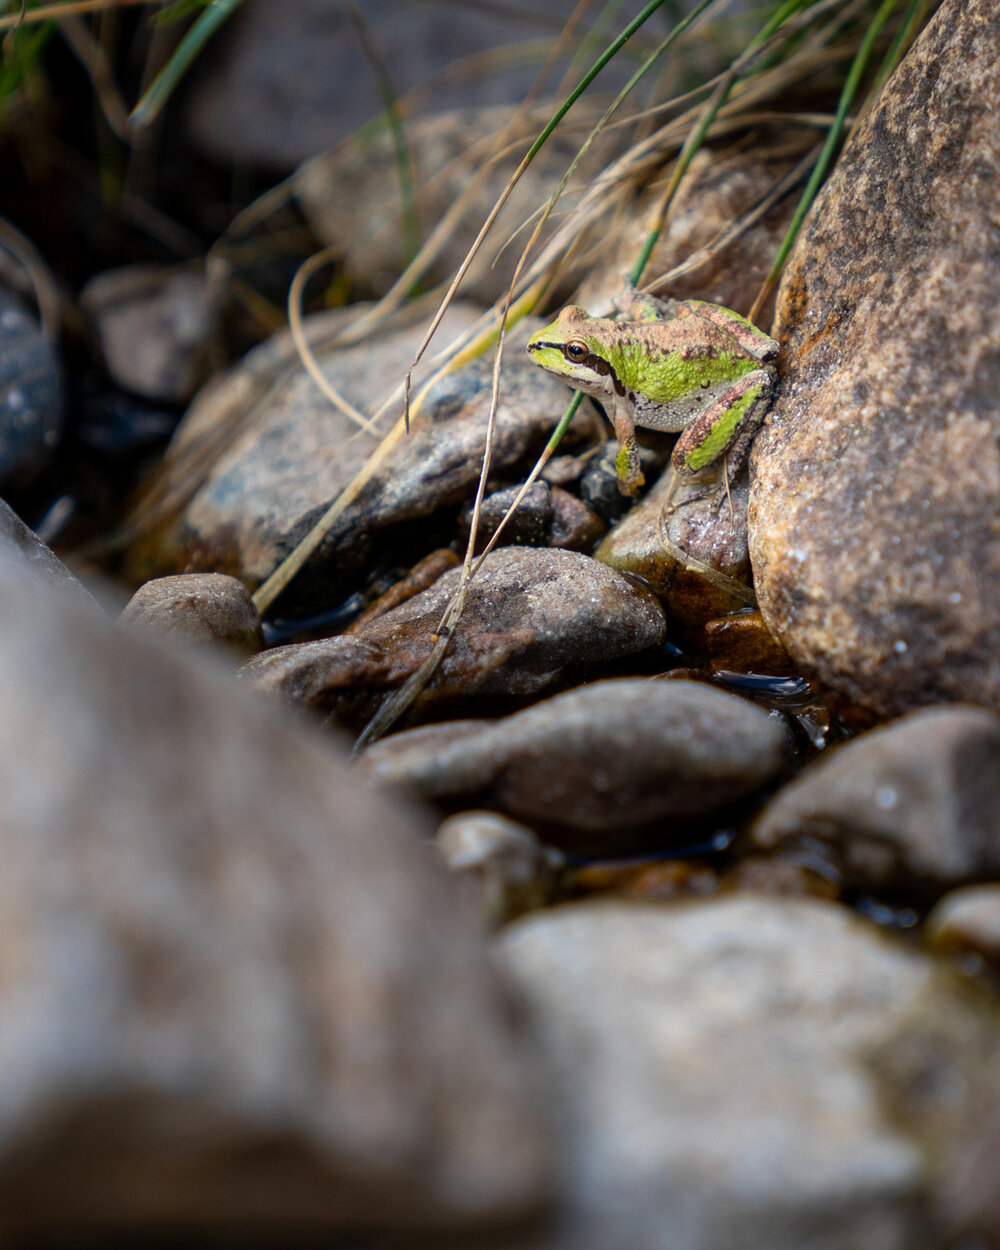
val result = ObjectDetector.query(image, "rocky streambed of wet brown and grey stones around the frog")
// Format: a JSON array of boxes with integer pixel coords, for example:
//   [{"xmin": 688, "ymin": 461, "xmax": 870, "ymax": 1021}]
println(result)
[{"xmin": 0, "ymin": 0, "xmax": 1000, "ymax": 1250}]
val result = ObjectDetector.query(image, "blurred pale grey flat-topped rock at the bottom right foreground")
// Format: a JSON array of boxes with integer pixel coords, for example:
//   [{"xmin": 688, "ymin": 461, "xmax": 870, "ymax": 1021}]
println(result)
[{"xmin": 498, "ymin": 896, "xmax": 996, "ymax": 1250}]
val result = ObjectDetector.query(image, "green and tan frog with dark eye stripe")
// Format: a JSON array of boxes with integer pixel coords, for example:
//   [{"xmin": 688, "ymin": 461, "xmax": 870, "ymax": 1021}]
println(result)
[{"xmin": 528, "ymin": 290, "xmax": 779, "ymax": 495}]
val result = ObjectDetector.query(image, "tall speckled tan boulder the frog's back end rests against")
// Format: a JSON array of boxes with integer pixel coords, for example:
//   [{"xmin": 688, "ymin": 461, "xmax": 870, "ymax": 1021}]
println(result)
[{"xmin": 750, "ymin": 0, "xmax": 1000, "ymax": 723}]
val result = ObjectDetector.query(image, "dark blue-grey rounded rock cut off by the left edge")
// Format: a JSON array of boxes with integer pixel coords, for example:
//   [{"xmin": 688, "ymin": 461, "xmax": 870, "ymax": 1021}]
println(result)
[{"xmin": 0, "ymin": 286, "xmax": 63, "ymax": 490}]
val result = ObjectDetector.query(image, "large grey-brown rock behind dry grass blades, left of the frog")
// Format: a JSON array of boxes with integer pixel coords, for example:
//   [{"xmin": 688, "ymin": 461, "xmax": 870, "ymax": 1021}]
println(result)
[{"xmin": 129, "ymin": 306, "xmax": 585, "ymax": 616}]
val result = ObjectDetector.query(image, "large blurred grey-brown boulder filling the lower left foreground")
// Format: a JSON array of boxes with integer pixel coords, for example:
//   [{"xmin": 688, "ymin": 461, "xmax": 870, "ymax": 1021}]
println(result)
[{"xmin": 0, "ymin": 550, "xmax": 549, "ymax": 1245}]
